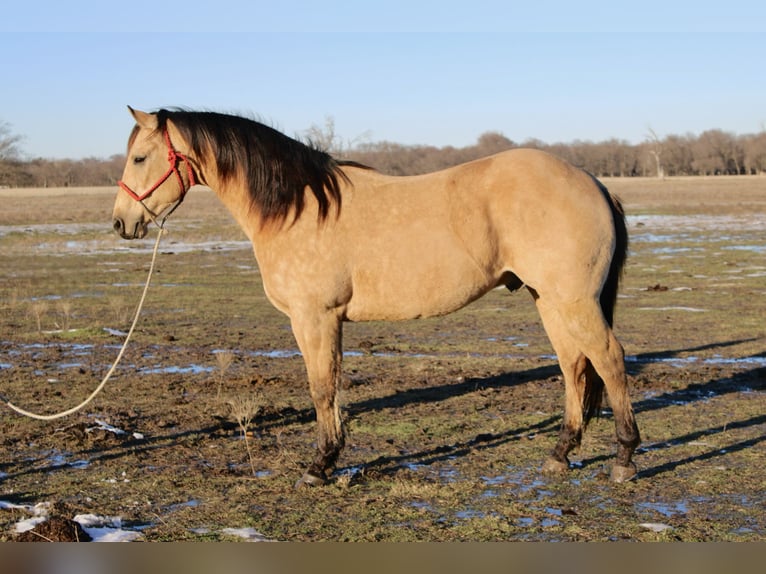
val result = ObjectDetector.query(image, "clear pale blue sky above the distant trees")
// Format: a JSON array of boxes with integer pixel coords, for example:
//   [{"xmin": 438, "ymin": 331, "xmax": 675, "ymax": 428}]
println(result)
[{"xmin": 0, "ymin": 0, "xmax": 766, "ymax": 158}]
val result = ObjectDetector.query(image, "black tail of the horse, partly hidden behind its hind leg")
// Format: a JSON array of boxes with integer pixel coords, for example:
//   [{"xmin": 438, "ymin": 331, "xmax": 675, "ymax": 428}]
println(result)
[{"xmin": 583, "ymin": 176, "xmax": 628, "ymax": 426}]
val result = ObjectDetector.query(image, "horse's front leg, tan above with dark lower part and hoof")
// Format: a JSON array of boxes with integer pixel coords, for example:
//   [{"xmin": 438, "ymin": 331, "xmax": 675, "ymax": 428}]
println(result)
[{"xmin": 292, "ymin": 311, "xmax": 345, "ymax": 487}]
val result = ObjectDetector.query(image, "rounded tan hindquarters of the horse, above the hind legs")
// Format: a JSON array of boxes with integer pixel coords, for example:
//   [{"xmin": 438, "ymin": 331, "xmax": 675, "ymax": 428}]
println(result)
[{"xmin": 436, "ymin": 149, "xmax": 615, "ymax": 295}]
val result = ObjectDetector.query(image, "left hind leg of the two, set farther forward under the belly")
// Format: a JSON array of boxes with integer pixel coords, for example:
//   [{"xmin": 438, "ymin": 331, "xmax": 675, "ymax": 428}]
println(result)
[{"xmin": 533, "ymin": 300, "xmax": 589, "ymax": 473}]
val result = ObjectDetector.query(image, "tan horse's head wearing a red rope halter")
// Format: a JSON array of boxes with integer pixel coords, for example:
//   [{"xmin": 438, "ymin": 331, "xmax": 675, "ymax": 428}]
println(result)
[{"xmin": 112, "ymin": 107, "xmax": 195, "ymax": 239}]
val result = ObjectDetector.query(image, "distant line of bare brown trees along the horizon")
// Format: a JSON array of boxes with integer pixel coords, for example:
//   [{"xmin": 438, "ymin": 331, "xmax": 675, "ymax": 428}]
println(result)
[{"xmin": 0, "ymin": 118, "xmax": 766, "ymax": 187}]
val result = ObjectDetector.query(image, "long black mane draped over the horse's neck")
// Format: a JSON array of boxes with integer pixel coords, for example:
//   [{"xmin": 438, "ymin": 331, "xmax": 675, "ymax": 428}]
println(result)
[{"xmin": 152, "ymin": 109, "xmax": 363, "ymax": 223}]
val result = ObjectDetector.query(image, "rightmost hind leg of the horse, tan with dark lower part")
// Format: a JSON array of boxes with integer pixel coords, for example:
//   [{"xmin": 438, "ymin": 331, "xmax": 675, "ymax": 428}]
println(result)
[{"xmin": 557, "ymin": 300, "xmax": 641, "ymax": 482}]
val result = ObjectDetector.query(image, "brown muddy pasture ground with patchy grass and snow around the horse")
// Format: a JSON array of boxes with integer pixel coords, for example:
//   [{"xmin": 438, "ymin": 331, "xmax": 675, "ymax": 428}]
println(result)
[{"xmin": 0, "ymin": 177, "xmax": 766, "ymax": 541}]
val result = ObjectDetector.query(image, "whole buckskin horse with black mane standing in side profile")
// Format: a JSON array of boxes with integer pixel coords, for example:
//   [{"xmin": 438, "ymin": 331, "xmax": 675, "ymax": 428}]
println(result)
[{"xmin": 112, "ymin": 107, "xmax": 640, "ymax": 486}]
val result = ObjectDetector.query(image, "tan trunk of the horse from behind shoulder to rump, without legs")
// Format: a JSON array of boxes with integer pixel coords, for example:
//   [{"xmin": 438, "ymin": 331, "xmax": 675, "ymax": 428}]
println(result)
[{"xmin": 334, "ymin": 149, "xmax": 614, "ymax": 320}]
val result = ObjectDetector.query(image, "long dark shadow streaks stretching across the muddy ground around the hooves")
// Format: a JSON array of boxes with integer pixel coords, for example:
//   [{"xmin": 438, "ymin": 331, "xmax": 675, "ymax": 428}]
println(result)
[{"xmin": 0, "ymin": 341, "xmax": 766, "ymax": 479}]
